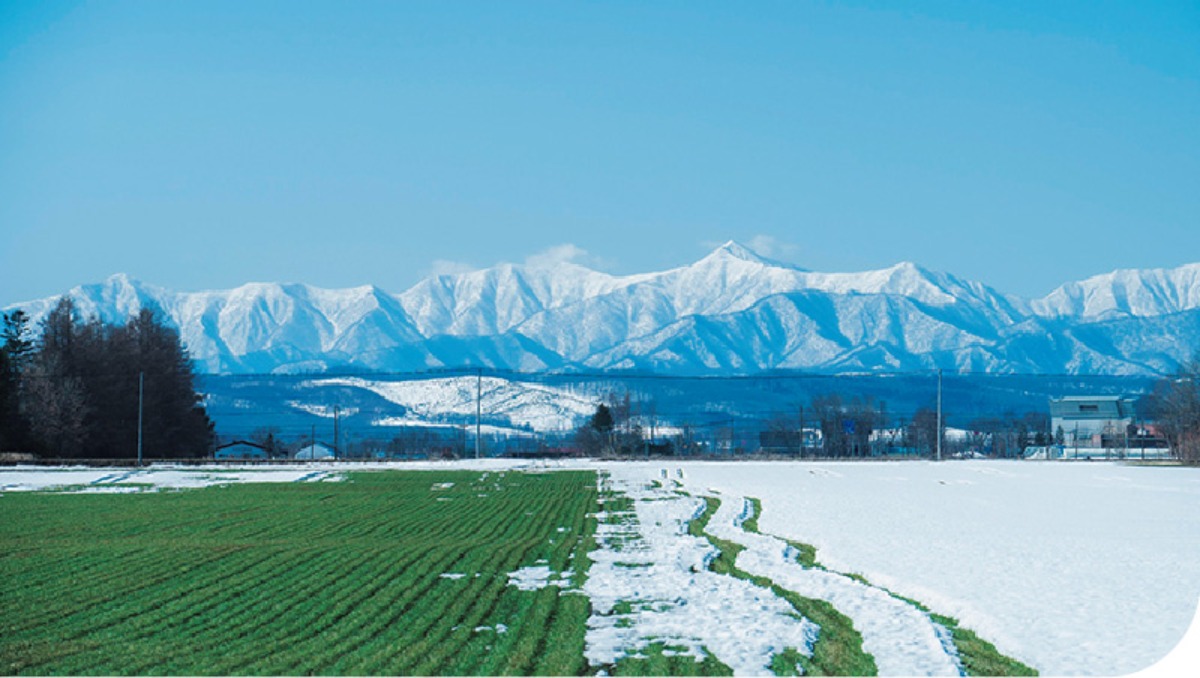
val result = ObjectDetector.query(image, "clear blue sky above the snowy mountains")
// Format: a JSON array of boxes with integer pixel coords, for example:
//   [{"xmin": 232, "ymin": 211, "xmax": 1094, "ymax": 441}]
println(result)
[{"xmin": 0, "ymin": 0, "xmax": 1200, "ymax": 305}]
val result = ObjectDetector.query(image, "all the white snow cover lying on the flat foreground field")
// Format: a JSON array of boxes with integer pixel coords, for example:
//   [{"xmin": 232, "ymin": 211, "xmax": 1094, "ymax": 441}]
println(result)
[{"xmin": 0, "ymin": 460, "xmax": 1200, "ymax": 676}]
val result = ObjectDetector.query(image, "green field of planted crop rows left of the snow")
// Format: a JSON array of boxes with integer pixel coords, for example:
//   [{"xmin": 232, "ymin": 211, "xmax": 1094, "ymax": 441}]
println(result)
[{"xmin": 0, "ymin": 472, "xmax": 598, "ymax": 676}]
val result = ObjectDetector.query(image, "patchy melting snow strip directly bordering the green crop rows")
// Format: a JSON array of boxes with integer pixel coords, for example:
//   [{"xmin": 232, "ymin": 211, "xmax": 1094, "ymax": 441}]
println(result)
[{"xmin": 583, "ymin": 473, "xmax": 816, "ymax": 676}]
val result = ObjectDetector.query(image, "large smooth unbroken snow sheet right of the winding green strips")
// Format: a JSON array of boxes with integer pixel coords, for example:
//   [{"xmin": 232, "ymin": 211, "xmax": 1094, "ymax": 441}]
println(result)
[{"xmin": 667, "ymin": 461, "xmax": 1200, "ymax": 674}]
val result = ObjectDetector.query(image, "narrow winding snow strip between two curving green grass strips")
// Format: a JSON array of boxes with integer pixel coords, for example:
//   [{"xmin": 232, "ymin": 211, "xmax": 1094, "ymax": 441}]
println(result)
[{"xmin": 707, "ymin": 490, "xmax": 965, "ymax": 676}]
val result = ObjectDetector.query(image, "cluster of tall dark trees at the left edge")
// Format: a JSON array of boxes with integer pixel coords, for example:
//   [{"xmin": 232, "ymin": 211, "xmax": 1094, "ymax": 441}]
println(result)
[{"xmin": 0, "ymin": 296, "xmax": 214, "ymax": 458}]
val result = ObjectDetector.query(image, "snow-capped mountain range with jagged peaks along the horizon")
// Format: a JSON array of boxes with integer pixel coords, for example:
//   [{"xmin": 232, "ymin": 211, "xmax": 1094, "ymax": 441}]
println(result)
[{"xmin": 6, "ymin": 241, "xmax": 1200, "ymax": 374}]
